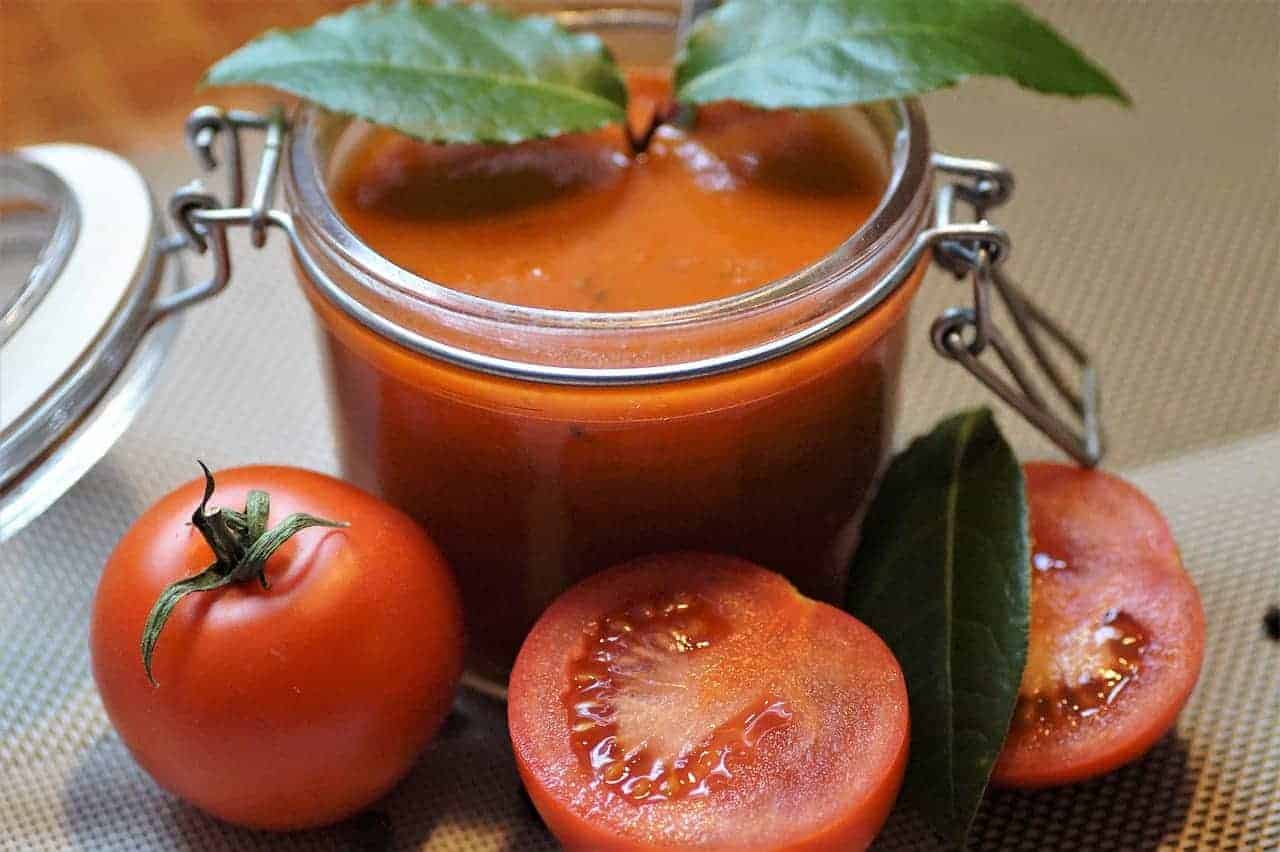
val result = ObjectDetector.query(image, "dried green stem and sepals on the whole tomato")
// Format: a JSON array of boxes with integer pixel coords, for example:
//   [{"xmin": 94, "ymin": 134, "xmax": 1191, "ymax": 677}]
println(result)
[{"xmin": 141, "ymin": 462, "xmax": 347, "ymax": 686}]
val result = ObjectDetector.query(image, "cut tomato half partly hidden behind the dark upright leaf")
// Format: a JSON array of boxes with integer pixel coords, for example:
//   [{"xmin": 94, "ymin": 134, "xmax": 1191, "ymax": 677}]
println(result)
[{"xmin": 992, "ymin": 462, "xmax": 1204, "ymax": 787}]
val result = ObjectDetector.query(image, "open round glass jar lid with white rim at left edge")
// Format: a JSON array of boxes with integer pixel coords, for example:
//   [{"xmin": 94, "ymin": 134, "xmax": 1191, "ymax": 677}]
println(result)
[{"xmin": 0, "ymin": 145, "xmax": 182, "ymax": 540}]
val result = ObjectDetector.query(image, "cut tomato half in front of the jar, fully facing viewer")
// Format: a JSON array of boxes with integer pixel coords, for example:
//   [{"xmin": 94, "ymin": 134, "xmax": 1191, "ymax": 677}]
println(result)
[{"xmin": 508, "ymin": 553, "xmax": 909, "ymax": 849}]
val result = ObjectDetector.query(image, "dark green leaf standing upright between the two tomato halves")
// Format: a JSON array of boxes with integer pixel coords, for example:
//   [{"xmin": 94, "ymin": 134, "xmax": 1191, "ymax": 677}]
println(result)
[{"xmin": 846, "ymin": 408, "xmax": 1030, "ymax": 844}]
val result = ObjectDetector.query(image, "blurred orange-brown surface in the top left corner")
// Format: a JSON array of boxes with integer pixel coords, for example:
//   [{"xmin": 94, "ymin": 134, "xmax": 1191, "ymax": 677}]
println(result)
[{"xmin": 0, "ymin": 0, "xmax": 348, "ymax": 150}]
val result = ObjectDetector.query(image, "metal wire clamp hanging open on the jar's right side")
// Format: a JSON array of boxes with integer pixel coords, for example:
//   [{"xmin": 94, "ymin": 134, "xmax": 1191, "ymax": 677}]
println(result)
[{"xmin": 929, "ymin": 154, "xmax": 1103, "ymax": 467}]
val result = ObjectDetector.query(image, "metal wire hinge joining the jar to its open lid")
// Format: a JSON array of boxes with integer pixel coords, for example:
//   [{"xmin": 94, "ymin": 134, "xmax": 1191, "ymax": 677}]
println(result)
[{"xmin": 148, "ymin": 106, "xmax": 289, "ymax": 324}]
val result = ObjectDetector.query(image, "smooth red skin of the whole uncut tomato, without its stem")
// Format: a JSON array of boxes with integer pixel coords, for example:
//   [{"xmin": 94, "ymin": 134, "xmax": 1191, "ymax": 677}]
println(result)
[{"xmin": 90, "ymin": 466, "xmax": 462, "ymax": 830}]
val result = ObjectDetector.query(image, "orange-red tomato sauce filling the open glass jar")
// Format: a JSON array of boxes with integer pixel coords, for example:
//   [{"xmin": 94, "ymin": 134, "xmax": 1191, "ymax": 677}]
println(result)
[{"xmin": 312, "ymin": 74, "xmax": 923, "ymax": 681}]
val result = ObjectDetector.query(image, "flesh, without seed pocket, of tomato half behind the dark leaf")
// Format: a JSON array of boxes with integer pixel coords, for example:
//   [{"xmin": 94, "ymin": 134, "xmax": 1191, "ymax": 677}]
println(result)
[{"xmin": 991, "ymin": 462, "xmax": 1204, "ymax": 788}]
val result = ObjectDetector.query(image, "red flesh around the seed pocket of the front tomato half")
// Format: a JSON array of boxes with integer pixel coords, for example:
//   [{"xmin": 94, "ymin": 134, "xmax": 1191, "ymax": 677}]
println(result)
[{"xmin": 508, "ymin": 553, "xmax": 909, "ymax": 852}]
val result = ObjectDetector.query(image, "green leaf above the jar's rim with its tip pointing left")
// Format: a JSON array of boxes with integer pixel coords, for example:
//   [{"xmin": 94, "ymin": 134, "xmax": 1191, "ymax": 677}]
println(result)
[{"xmin": 204, "ymin": 0, "xmax": 627, "ymax": 142}]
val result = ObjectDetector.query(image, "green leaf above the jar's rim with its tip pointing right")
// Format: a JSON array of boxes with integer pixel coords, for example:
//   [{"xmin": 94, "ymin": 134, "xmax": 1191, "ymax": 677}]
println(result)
[{"xmin": 676, "ymin": 0, "xmax": 1129, "ymax": 109}]
